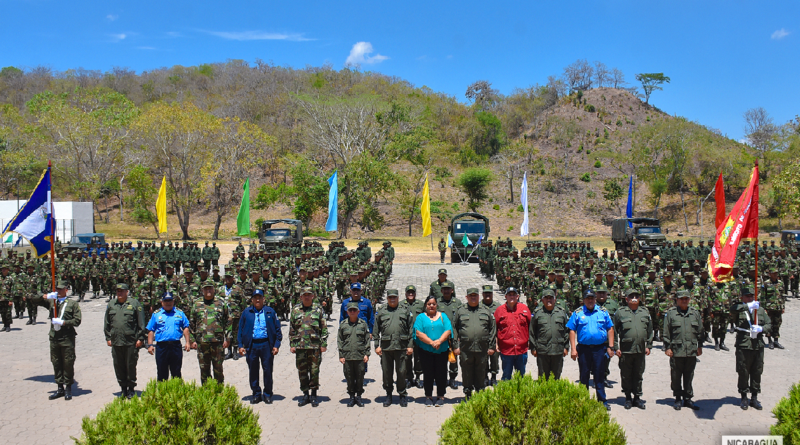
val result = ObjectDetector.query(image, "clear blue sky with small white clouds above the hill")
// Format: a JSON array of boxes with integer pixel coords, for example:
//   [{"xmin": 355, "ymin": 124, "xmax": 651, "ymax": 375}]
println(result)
[{"xmin": 0, "ymin": 0, "xmax": 800, "ymax": 139}]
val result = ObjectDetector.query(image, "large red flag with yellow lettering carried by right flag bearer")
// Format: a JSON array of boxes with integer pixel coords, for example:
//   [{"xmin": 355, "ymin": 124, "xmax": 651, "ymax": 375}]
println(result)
[{"xmin": 708, "ymin": 166, "xmax": 758, "ymax": 283}]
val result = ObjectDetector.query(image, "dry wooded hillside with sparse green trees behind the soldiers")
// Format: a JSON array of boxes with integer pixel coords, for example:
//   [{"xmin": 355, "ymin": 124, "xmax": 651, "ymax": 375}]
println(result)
[{"xmin": 0, "ymin": 60, "xmax": 800, "ymax": 239}]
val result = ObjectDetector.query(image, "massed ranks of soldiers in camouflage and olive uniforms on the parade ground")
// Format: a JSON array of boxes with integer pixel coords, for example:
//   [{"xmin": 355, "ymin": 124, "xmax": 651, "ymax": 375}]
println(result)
[{"xmin": 9, "ymin": 239, "xmax": 800, "ymax": 409}]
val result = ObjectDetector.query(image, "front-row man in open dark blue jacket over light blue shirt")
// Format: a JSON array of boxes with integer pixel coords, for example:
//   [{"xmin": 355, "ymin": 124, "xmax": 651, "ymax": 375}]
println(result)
[{"xmin": 238, "ymin": 289, "xmax": 283, "ymax": 405}]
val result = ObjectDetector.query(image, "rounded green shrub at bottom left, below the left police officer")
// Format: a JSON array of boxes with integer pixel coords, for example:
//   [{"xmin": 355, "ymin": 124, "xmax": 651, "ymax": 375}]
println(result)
[{"xmin": 72, "ymin": 379, "xmax": 261, "ymax": 445}]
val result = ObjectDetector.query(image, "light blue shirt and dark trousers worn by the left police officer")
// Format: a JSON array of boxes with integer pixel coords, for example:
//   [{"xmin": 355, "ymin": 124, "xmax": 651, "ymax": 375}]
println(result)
[{"xmin": 147, "ymin": 308, "xmax": 189, "ymax": 381}]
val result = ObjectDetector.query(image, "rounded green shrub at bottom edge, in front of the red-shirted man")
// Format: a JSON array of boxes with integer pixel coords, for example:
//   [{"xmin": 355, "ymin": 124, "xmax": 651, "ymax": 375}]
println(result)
[{"xmin": 439, "ymin": 373, "xmax": 625, "ymax": 445}]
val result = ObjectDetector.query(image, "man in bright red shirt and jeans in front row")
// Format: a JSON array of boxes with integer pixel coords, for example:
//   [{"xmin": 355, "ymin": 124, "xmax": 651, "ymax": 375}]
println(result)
[{"xmin": 494, "ymin": 287, "xmax": 531, "ymax": 380}]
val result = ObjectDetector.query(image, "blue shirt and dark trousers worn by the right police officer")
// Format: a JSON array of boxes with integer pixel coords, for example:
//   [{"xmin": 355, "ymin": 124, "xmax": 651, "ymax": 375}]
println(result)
[{"xmin": 567, "ymin": 305, "xmax": 614, "ymax": 406}]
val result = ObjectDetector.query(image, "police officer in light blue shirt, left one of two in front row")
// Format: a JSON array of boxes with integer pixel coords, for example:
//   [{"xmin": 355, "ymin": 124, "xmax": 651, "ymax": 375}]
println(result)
[{"xmin": 147, "ymin": 292, "xmax": 191, "ymax": 381}]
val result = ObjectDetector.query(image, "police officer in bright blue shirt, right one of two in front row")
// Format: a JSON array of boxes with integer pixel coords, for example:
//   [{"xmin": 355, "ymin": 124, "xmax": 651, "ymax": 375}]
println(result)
[{"xmin": 567, "ymin": 289, "xmax": 614, "ymax": 411}]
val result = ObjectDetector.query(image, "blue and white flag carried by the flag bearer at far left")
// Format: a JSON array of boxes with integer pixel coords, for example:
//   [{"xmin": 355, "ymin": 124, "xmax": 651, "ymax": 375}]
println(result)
[{"xmin": 2, "ymin": 168, "xmax": 54, "ymax": 258}]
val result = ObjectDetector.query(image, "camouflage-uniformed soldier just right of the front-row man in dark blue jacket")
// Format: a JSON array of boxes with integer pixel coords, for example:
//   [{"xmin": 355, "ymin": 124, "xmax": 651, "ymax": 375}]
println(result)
[{"xmin": 289, "ymin": 286, "xmax": 328, "ymax": 407}]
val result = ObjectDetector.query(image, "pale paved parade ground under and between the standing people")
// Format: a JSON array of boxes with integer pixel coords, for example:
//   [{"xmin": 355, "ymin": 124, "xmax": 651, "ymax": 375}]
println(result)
[{"xmin": 0, "ymin": 264, "xmax": 800, "ymax": 445}]
